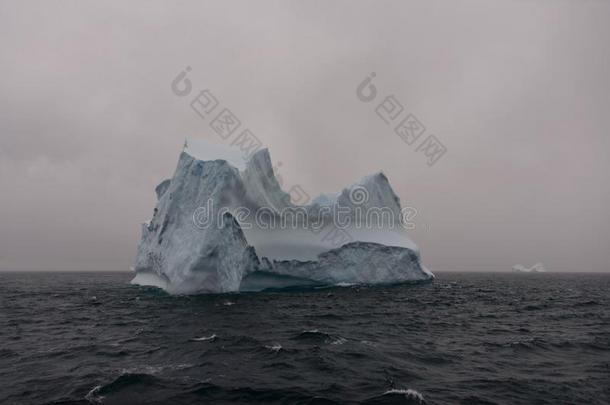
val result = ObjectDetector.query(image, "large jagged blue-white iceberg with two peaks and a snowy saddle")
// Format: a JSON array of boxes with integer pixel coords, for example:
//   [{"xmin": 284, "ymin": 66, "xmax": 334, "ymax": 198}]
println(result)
[{"xmin": 132, "ymin": 139, "xmax": 434, "ymax": 294}]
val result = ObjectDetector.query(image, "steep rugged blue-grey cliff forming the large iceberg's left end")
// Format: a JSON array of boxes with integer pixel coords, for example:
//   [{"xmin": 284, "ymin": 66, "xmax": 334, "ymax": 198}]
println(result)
[{"xmin": 134, "ymin": 153, "xmax": 257, "ymax": 293}]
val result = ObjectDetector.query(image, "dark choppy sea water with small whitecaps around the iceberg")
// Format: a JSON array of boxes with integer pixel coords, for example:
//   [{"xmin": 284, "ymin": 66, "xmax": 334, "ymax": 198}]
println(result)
[{"xmin": 0, "ymin": 273, "xmax": 610, "ymax": 404}]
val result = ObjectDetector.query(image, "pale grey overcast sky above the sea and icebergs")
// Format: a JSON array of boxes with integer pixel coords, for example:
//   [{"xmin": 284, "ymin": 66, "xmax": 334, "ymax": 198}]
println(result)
[{"xmin": 0, "ymin": 0, "xmax": 610, "ymax": 271}]
